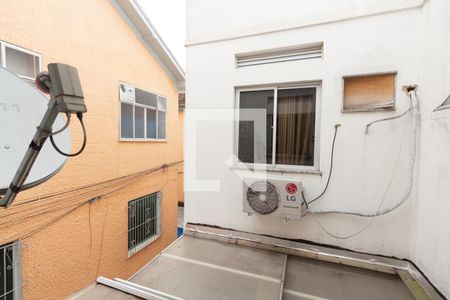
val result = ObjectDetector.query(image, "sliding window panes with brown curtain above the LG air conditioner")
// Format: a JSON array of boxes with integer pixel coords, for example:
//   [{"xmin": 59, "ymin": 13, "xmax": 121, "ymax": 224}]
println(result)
[{"xmin": 237, "ymin": 86, "xmax": 318, "ymax": 169}]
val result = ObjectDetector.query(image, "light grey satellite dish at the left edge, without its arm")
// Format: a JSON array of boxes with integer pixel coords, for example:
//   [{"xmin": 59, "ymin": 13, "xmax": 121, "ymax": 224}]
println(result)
[{"xmin": 0, "ymin": 67, "xmax": 71, "ymax": 194}]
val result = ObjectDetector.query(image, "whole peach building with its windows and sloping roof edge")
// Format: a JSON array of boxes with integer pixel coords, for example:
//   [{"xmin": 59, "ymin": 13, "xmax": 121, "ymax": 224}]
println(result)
[{"xmin": 0, "ymin": 0, "xmax": 184, "ymax": 299}]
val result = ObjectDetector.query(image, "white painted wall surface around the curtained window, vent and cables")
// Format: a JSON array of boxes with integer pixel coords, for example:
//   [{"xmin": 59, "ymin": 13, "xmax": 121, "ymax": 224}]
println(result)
[{"xmin": 185, "ymin": 0, "xmax": 450, "ymax": 295}]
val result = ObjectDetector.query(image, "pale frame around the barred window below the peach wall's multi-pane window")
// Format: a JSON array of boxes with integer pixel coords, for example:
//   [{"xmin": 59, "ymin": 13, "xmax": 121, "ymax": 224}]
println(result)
[{"xmin": 127, "ymin": 192, "xmax": 162, "ymax": 258}]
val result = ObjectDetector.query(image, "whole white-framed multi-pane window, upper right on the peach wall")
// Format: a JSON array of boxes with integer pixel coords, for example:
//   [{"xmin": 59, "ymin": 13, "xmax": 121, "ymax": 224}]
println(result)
[{"xmin": 119, "ymin": 83, "xmax": 167, "ymax": 140}]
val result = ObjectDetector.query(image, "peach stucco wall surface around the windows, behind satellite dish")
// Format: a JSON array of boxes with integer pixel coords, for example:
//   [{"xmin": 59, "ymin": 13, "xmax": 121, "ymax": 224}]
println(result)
[{"xmin": 0, "ymin": 0, "xmax": 182, "ymax": 299}]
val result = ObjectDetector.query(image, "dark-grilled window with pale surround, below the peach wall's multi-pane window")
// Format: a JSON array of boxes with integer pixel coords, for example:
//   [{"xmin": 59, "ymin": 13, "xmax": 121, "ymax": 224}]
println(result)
[{"xmin": 127, "ymin": 193, "xmax": 161, "ymax": 256}]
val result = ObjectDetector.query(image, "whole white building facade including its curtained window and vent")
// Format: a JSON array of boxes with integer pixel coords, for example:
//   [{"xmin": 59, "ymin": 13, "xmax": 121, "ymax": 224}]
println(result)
[{"xmin": 185, "ymin": 0, "xmax": 450, "ymax": 297}]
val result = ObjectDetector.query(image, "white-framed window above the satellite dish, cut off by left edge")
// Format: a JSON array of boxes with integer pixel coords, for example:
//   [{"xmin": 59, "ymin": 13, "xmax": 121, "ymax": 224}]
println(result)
[{"xmin": 0, "ymin": 41, "xmax": 41, "ymax": 85}]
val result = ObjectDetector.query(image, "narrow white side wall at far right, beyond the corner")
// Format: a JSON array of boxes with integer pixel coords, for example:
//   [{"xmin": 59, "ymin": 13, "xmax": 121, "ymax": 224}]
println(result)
[{"xmin": 411, "ymin": 0, "xmax": 450, "ymax": 298}]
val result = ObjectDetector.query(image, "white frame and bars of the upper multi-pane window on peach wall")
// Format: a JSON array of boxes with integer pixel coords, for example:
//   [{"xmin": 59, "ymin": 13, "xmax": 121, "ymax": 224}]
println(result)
[{"xmin": 117, "ymin": 81, "xmax": 169, "ymax": 142}]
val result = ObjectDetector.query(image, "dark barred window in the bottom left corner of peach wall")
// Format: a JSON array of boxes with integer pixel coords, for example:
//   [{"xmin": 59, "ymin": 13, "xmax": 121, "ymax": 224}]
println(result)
[{"xmin": 0, "ymin": 242, "xmax": 22, "ymax": 300}]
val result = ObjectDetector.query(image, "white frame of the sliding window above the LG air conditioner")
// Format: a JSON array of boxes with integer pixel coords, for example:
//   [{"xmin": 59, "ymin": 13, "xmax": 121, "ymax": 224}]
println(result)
[{"xmin": 234, "ymin": 81, "xmax": 322, "ymax": 174}]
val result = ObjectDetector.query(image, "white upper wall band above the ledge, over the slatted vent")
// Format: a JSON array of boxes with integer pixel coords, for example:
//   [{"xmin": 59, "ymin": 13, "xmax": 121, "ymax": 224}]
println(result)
[{"xmin": 187, "ymin": 0, "xmax": 426, "ymax": 44}]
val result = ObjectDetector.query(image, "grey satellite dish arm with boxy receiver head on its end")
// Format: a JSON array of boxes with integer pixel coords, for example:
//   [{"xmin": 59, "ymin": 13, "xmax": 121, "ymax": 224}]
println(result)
[{"xmin": 0, "ymin": 63, "xmax": 87, "ymax": 208}]
